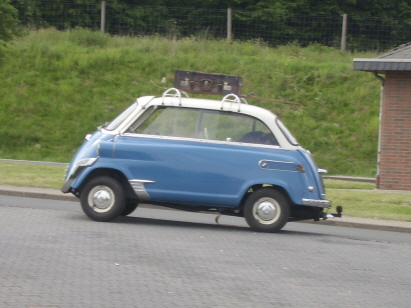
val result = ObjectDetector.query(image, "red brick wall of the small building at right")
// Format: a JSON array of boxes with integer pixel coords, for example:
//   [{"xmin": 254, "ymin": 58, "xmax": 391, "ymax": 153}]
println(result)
[{"xmin": 379, "ymin": 71, "xmax": 411, "ymax": 191}]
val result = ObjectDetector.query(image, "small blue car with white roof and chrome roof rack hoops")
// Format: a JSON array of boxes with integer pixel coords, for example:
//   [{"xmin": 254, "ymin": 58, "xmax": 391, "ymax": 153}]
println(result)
[{"xmin": 61, "ymin": 88, "xmax": 338, "ymax": 232}]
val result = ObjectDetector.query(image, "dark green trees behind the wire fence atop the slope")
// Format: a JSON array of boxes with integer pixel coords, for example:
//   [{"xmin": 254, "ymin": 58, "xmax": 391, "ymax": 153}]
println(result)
[{"xmin": 4, "ymin": 0, "xmax": 411, "ymax": 50}]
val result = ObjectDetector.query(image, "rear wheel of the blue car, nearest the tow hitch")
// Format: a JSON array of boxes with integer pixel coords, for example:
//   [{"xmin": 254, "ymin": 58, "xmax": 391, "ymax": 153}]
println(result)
[{"xmin": 244, "ymin": 188, "xmax": 290, "ymax": 232}]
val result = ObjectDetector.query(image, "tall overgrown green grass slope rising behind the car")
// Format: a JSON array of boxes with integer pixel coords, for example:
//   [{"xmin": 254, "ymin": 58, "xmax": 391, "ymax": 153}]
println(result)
[{"xmin": 0, "ymin": 29, "xmax": 380, "ymax": 176}]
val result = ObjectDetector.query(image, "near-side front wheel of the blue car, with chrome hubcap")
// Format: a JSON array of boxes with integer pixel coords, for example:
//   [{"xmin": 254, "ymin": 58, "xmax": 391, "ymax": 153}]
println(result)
[{"xmin": 80, "ymin": 176, "xmax": 126, "ymax": 221}]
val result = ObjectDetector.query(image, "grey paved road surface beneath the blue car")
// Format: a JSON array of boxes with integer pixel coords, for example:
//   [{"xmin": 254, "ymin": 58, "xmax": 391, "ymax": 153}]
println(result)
[{"xmin": 0, "ymin": 196, "xmax": 411, "ymax": 308}]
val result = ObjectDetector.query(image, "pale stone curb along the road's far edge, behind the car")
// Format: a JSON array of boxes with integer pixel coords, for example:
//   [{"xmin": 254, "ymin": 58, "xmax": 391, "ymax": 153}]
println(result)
[{"xmin": 0, "ymin": 185, "xmax": 411, "ymax": 233}]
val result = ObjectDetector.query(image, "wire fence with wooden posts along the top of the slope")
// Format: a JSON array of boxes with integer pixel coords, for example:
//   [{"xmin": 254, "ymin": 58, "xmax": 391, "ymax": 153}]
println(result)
[{"xmin": 14, "ymin": 0, "xmax": 411, "ymax": 51}]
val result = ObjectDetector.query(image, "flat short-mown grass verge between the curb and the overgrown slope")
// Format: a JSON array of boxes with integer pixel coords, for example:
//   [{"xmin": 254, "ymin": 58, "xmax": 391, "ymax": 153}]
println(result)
[{"xmin": 0, "ymin": 162, "xmax": 411, "ymax": 221}]
